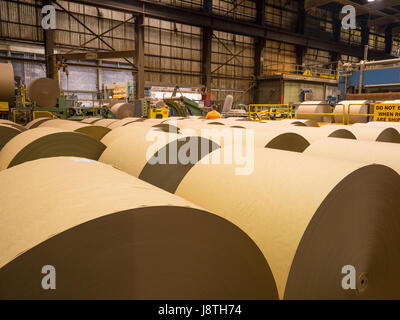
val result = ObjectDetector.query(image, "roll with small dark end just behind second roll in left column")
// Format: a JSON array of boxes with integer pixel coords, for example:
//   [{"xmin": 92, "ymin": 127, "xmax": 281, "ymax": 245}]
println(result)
[{"xmin": 39, "ymin": 119, "xmax": 111, "ymax": 140}]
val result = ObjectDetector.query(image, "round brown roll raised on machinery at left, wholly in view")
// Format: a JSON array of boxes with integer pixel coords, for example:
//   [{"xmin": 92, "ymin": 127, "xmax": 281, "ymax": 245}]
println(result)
[{"xmin": 28, "ymin": 78, "xmax": 60, "ymax": 108}]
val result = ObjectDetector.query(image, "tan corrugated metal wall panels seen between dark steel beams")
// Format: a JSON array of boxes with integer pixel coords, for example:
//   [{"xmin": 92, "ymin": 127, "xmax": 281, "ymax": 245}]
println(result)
[{"xmin": 0, "ymin": 0, "xmax": 400, "ymax": 103}]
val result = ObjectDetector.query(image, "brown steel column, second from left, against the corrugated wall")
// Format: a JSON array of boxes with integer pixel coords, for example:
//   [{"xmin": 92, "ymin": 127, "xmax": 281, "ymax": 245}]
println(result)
[{"xmin": 135, "ymin": 14, "xmax": 145, "ymax": 99}]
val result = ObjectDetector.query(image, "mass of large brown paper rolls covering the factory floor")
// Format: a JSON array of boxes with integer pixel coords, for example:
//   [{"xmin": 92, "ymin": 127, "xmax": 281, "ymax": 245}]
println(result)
[{"xmin": 0, "ymin": 118, "xmax": 400, "ymax": 299}]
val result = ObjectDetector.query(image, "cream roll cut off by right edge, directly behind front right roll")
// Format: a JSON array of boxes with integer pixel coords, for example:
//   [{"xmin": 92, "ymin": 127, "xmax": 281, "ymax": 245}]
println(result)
[{"xmin": 304, "ymin": 138, "xmax": 400, "ymax": 174}]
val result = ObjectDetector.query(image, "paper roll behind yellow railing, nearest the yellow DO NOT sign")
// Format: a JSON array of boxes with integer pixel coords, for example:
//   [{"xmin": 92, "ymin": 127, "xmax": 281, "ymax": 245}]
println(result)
[{"xmin": 333, "ymin": 100, "xmax": 368, "ymax": 124}]
